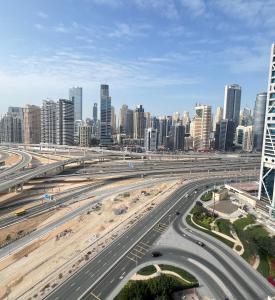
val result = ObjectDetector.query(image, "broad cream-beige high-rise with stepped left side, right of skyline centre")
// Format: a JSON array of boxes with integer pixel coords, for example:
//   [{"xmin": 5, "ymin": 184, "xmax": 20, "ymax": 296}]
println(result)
[{"xmin": 192, "ymin": 105, "xmax": 211, "ymax": 151}]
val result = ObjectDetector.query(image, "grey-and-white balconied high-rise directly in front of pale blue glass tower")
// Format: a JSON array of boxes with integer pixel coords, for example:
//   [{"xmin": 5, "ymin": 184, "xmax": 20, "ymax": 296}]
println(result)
[{"xmin": 56, "ymin": 99, "xmax": 75, "ymax": 145}]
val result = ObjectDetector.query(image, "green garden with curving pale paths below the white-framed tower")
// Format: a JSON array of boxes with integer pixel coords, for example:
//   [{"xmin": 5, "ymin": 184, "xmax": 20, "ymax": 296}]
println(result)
[{"xmin": 189, "ymin": 205, "xmax": 275, "ymax": 286}]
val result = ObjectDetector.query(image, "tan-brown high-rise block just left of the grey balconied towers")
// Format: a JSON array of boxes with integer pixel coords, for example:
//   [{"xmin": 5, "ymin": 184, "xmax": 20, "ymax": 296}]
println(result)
[{"xmin": 23, "ymin": 105, "xmax": 41, "ymax": 144}]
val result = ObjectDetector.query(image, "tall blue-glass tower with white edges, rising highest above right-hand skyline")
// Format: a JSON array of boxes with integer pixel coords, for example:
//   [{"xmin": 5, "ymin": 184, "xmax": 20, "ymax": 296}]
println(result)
[{"xmin": 223, "ymin": 84, "xmax": 242, "ymax": 127}]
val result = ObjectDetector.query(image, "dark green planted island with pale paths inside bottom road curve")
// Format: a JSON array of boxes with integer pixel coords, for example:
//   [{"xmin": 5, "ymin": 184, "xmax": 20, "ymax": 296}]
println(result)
[{"xmin": 115, "ymin": 265, "xmax": 199, "ymax": 300}]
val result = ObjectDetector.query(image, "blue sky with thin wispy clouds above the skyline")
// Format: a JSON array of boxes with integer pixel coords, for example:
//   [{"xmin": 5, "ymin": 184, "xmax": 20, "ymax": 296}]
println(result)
[{"xmin": 0, "ymin": 0, "xmax": 275, "ymax": 117}]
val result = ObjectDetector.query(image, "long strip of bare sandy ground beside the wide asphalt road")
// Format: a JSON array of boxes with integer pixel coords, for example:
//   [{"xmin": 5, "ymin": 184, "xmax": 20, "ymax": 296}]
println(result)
[{"xmin": 0, "ymin": 182, "xmax": 179, "ymax": 299}]
